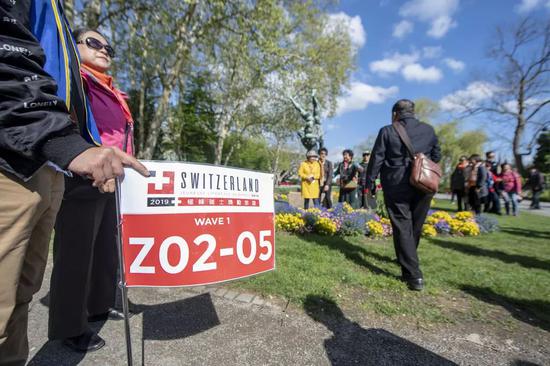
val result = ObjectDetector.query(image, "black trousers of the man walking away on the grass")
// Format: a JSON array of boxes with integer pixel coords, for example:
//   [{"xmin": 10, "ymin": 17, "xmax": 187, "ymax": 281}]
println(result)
[{"xmin": 384, "ymin": 187, "xmax": 433, "ymax": 280}]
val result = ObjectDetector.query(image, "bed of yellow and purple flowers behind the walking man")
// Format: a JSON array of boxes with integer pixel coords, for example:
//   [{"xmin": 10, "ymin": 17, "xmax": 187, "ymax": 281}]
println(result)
[{"xmin": 275, "ymin": 201, "xmax": 498, "ymax": 238}]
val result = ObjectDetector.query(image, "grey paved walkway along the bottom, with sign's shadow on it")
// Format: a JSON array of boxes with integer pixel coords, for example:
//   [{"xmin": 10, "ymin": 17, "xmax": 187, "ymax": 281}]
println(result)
[{"xmin": 23, "ymin": 261, "xmax": 550, "ymax": 366}]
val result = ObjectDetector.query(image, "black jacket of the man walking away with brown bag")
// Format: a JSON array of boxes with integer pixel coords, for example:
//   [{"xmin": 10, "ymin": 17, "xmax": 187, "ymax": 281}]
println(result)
[{"xmin": 366, "ymin": 118, "xmax": 441, "ymax": 192}]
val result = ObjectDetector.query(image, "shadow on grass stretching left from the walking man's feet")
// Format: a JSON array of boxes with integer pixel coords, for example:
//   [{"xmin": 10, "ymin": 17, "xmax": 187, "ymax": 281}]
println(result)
[{"xmin": 300, "ymin": 235, "xmax": 400, "ymax": 280}]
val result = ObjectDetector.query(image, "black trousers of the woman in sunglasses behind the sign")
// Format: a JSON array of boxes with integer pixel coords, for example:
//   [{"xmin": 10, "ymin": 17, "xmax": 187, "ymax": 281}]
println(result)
[{"xmin": 48, "ymin": 178, "xmax": 118, "ymax": 339}]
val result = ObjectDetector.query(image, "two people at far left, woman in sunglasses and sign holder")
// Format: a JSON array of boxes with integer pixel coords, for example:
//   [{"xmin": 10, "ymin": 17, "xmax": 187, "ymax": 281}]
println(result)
[{"xmin": 0, "ymin": 0, "xmax": 149, "ymax": 365}]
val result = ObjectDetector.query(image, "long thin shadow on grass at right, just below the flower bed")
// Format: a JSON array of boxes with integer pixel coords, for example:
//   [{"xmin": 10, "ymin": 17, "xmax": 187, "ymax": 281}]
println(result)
[{"xmin": 429, "ymin": 239, "xmax": 550, "ymax": 271}]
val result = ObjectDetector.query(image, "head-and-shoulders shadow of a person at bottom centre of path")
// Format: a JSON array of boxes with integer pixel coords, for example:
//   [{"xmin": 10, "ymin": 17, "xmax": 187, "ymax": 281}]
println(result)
[{"xmin": 304, "ymin": 295, "xmax": 456, "ymax": 366}]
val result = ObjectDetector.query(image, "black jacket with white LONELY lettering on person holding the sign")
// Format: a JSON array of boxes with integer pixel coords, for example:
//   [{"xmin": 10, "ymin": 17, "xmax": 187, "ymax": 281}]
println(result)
[{"xmin": 0, "ymin": 0, "xmax": 92, "ymax": 179}]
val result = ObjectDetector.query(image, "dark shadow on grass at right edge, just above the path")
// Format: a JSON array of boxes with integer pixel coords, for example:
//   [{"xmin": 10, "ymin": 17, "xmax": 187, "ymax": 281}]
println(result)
[{"xmin": 461, "ymin": 285, "xmax": 550, "ymax": 331}]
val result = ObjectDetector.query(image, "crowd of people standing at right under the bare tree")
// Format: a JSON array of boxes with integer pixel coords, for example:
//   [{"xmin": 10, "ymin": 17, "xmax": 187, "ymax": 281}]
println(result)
[{"xmin": 451, "ymin": 151, "xmax": 545, "ymax": 216}]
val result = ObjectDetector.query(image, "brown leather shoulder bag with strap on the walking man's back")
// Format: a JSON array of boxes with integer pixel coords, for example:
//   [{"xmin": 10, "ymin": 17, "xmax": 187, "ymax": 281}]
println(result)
[{"xmin": 392, "ymin": 122, "xmax": 441, "ymax": 194}]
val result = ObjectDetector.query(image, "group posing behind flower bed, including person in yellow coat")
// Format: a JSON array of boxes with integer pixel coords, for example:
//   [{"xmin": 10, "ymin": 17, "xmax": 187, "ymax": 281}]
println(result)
[{"xmin": 298, "ymin": 147, "xmax": 376, "ymax": 209}]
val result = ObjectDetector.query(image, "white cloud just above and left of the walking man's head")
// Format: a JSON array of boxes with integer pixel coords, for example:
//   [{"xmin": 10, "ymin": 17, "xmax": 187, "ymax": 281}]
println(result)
[{"xmin": 336, "ymin": 81, "xmax": 399, "ymax": 115}]
